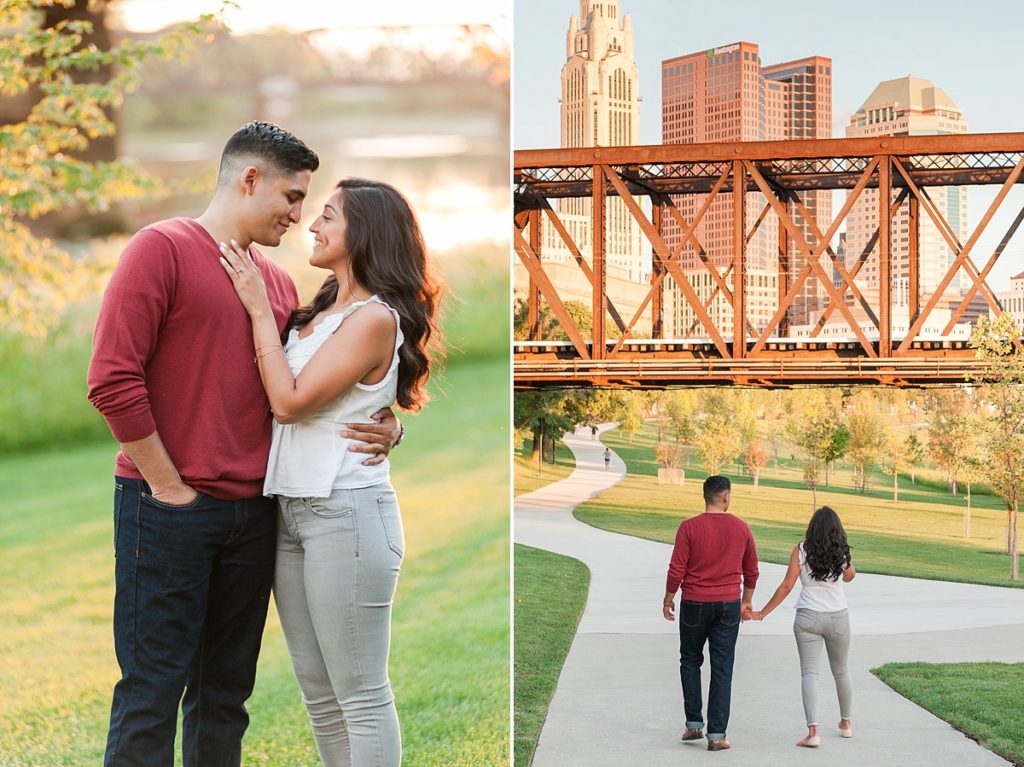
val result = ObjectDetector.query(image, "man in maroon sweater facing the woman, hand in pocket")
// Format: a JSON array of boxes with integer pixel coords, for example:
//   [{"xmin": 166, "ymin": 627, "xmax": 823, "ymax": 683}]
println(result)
[{"xmin": 88, "ymin": 123, "xmax": 398, "ymax": 767}]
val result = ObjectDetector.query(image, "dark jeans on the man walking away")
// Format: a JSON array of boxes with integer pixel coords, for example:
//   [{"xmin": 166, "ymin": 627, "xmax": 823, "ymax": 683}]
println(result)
[{"xmin": 679, "ymin": 599, "xmax": 739, "ymax": 740}]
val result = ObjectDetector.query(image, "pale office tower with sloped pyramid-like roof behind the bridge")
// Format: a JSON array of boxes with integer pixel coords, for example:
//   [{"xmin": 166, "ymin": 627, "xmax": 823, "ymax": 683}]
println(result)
[{"xmin": 846, "ymin": 77, "xmax": 976, "ymax": 305}]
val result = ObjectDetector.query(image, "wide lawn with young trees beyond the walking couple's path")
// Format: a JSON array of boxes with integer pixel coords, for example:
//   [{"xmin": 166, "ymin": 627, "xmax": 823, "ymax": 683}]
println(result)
[{"xmin": 574, "ymin": 427, "xmax": 1024, "ymax": 588}]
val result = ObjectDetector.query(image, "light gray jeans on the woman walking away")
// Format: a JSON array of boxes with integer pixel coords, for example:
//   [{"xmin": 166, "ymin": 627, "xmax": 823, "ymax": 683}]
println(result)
[{"xmin": 793, "ymin": 607, "xmax": 853, "ymax": 727}]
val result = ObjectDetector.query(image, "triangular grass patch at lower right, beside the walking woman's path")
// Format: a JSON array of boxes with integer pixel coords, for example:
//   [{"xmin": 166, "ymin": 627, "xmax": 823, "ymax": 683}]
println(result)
[{"xmin": 871, "ymin": 663, "xmax": 1024, "ymax": 767}]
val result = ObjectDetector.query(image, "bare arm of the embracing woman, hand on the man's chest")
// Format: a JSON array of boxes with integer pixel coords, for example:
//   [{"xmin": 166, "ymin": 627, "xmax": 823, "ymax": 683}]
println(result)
[{"xmin": 221, "ymin": 243, "xmax": 396, "ymax": 424}]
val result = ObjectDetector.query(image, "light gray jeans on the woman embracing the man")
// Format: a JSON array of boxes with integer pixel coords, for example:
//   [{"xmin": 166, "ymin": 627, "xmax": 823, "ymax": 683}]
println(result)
[{"xmin": 273, "ymin": 484, "xmax": 404, "ymax": 767}]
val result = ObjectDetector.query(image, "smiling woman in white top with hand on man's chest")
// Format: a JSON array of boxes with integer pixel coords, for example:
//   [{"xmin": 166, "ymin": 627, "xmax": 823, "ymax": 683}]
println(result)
[{"xmin": 221, "ymin": 179, "xmax": 439, "ymax": 767}]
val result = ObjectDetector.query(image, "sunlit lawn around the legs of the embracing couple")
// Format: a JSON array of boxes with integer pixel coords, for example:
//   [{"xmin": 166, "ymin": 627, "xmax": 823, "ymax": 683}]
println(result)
[{"xmin": 0, "ymin": 358, "xmax": 510, "ymax": 767}]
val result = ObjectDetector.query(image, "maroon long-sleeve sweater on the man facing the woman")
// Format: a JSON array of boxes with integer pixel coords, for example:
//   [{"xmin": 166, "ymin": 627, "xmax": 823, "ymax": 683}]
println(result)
[{"xmin": 88, "ymin": 218, "xmax": 298, "ymax": 500}]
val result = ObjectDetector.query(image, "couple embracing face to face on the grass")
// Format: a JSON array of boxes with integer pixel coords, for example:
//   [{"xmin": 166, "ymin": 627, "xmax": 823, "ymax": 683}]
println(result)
[{"xmin": 88, "ymin": 122, "xmax": 438, "ymax": 767}]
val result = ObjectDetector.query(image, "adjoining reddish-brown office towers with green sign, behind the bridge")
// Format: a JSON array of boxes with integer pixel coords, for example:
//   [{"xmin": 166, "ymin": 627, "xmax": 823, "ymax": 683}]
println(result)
[{"xmin": 662, "ymin": 42, "xmax": 831, "ymax": 335}]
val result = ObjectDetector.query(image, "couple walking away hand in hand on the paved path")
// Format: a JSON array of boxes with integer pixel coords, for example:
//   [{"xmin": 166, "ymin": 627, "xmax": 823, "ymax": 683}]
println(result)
[{"xmin": 663, "ymin": 476, "xmax": 856, "ymax": 751}]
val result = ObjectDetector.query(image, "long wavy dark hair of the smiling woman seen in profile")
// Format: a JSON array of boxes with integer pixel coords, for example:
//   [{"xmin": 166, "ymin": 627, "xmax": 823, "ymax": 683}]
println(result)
[{"xmin": 285, "ymin": 178, "xmax": 440, "ymax": 411}]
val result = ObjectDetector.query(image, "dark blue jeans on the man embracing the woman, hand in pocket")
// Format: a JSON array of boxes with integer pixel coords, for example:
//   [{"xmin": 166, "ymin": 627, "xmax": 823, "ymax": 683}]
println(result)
[{"xmin": 103, "ymin": 477, "xmax": 276, "ymax": 767}]
